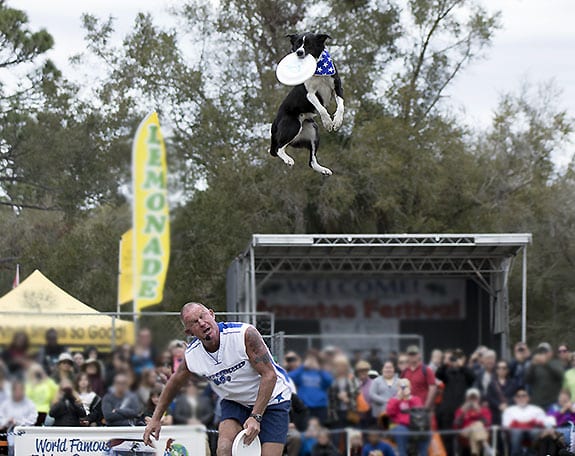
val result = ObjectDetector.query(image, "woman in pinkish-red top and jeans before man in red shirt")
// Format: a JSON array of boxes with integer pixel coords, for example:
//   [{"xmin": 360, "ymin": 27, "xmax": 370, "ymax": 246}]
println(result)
[{"xmin": 387, "ymin": 378, "xmax": 429, "ymax": 456}]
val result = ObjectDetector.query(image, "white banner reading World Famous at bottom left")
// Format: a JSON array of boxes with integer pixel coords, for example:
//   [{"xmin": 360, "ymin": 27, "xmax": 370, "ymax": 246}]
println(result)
[{"xmin": 14, "ymin": 426, "xmax": 206, "ymax": 456}]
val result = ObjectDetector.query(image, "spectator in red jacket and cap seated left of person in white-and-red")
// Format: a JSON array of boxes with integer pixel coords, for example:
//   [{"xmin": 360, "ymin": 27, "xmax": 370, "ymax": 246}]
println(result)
[{"xmin": 453, "ymin": 388, "xmax": 491, "ymax": 455}]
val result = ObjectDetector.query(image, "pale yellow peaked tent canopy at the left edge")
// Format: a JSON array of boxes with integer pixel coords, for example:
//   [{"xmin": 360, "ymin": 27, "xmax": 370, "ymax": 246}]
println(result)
[{"xmin": 0, "ymin": 271, "xmax": 134, "ymax": 348}]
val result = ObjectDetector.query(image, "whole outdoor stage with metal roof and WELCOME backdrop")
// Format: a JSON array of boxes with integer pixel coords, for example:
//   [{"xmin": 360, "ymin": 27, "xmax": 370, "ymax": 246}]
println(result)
[{"xmin": 227, "ymin": 233, "xmax": 531, "ymax": 353}]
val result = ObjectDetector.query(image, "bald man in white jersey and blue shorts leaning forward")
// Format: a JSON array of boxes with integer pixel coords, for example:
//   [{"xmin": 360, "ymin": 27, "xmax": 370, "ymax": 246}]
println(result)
[{"xmin": 144, "ymin": 302, "xmax": 292, "ymax": 456}]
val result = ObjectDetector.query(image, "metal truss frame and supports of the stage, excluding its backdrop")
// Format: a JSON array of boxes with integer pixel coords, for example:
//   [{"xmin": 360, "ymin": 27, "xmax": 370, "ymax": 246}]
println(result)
[{"xmin": 227, "ymin": 233, "xmax": 531, "ymax": 350}]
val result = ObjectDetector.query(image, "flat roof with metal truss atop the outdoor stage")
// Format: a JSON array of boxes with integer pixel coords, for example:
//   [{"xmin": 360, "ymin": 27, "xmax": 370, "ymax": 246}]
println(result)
[{"xmin": 245, "ymin": 233, "xmax": 531, "ymax": 276}]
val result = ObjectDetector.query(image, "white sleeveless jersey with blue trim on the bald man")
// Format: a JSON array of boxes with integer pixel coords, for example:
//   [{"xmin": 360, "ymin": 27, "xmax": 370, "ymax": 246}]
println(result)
[{"xmin": 186, "ymin": 323, "xmax": 292, "ymax": 407}]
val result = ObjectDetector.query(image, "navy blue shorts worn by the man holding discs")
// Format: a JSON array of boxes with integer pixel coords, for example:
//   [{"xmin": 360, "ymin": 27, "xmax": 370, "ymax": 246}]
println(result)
[{"xmin": 221, "ymin": 399, "xmax": 291, "ymax": 445}]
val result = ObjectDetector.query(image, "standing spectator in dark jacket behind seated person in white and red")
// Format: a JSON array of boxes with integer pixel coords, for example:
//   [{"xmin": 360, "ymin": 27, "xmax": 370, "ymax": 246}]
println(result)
[{"xmin": 525, "ymin": 342, "xmax": 565, "ymax": 410}]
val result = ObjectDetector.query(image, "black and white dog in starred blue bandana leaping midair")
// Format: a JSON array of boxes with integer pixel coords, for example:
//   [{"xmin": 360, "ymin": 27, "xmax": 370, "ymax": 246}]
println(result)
[{"xmin": 270, "ymin": 33, "xmax": 344, "ymax": 176}]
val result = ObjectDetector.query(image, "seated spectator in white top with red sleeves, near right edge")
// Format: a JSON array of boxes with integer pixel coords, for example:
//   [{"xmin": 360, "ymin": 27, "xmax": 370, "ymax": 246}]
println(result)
[{"xmin": 502, "ymin": 387, "xmax": 555, "ymax": 456}]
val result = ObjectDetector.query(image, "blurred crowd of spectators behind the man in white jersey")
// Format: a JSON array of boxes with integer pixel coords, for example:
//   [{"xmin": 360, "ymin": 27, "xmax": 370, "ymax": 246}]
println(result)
[{"xmin": 0, "ymin": 328, "xmax": 575, "ymax": 456}]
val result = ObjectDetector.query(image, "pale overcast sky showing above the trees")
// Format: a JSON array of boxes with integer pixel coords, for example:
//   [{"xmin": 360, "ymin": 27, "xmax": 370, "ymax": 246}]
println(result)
[{"xmin": 12, "ymin": 0, "xmax": 575, "ymax": 166}]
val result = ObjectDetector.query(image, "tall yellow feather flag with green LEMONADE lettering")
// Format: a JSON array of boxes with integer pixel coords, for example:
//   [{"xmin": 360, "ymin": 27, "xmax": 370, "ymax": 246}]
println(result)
[{"xmin": 132, "ymin": 112, "xmax": 170, "ymax": 311}]
